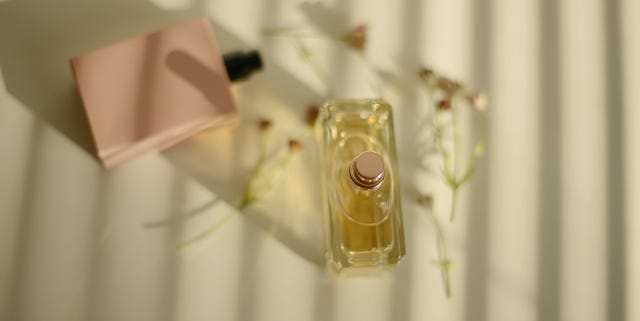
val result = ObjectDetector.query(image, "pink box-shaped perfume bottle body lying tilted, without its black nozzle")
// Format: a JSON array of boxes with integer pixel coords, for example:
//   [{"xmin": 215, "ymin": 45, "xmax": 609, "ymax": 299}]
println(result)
[{"xmin": 71, "ymin": 18, "xmax": 238, "ymax": 168}]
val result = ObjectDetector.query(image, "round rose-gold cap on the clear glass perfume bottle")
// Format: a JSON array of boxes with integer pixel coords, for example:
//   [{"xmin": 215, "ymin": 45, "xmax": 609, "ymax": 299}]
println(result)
[{"xmin": 349, "ymin": 151, "xmax": 385, "ymax": 188}]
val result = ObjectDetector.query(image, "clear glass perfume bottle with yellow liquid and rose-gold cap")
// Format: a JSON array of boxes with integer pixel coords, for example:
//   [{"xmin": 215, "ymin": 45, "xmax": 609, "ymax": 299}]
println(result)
[{"xmin": 316, "ymin": 100, "xmax": 405, "ymax": 270}]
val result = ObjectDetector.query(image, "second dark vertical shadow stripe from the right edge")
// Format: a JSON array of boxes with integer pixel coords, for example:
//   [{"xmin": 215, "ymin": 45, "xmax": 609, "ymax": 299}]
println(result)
[{"xmin": 537, "ymin": 0, "xmax": 562, "ymax": 321}]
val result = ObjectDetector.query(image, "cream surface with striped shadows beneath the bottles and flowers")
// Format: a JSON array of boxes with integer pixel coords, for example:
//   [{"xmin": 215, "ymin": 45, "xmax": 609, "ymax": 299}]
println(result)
[{"xmin": 0, "ymin": 0, "xmax": 640, "ymax": 321}]
